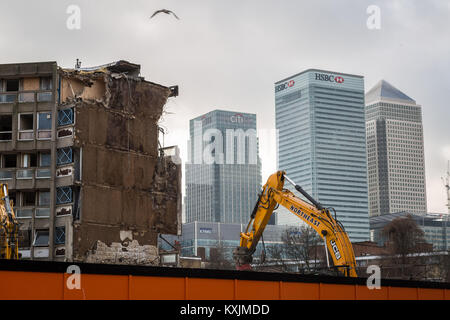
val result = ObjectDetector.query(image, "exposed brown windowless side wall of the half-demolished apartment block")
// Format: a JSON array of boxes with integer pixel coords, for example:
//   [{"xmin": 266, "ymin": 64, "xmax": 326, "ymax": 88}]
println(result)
[{"xmin": 61, "ymin": 69, "xmax": 181, "ymax": 263}]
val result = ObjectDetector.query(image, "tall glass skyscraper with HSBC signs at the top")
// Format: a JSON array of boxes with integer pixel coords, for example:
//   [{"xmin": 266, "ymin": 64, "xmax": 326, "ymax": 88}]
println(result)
[{"xmin": 275, "ymin": 69, "xmax": 369, "ymax": 242}]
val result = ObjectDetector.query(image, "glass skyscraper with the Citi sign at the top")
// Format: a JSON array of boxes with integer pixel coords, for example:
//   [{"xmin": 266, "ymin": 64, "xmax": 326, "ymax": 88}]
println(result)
[{"xmin": 185, "ymin": 110, "xmax": 261, "ymax": 225}]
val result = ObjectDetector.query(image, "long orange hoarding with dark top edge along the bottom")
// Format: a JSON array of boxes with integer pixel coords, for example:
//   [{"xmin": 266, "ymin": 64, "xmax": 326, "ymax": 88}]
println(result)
[{"xmin": 0, "ymin": 261, "xmax": 450, "ymax": 300}]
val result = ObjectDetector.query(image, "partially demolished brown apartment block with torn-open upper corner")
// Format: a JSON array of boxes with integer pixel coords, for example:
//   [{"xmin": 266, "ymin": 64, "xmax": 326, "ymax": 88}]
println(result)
[{"xmin": 0, "ymin": 61, "xmax": 181, "ymax": 264}]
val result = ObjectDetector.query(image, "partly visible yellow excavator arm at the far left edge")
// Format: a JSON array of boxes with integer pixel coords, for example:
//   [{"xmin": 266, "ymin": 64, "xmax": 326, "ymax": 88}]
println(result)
[{"xmin": 0, "ymin": 183, "xmax": 19, "ymax": 259}]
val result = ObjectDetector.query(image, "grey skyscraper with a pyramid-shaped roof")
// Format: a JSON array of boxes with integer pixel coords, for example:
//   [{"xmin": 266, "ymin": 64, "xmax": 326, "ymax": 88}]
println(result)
[{"xmin": 365, "ymin": 80, "xmax": 427, "ymax": 216}]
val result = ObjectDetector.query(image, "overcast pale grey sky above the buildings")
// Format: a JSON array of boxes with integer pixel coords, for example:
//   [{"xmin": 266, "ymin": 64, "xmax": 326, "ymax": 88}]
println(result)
[{"xmin": 0, "ymin": 0, "xmax": 450, "ymax": 212}]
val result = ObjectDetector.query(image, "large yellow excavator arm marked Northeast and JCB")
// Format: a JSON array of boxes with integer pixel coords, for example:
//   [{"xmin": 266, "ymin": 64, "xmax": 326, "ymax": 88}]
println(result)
[{"xmin": 233, "ymin": 171, "xmax": 357, "ymax": 277}]
